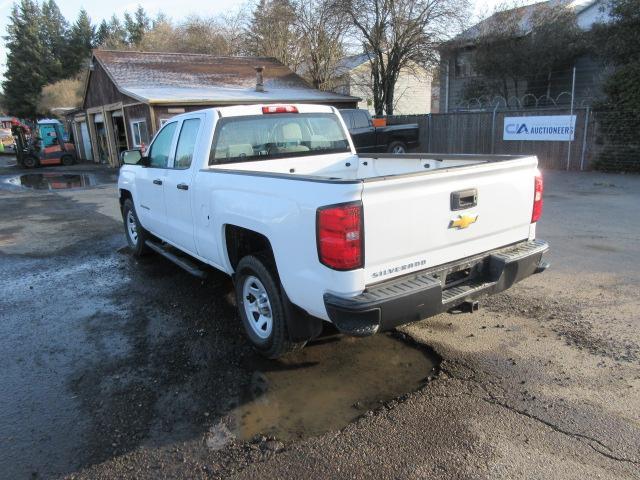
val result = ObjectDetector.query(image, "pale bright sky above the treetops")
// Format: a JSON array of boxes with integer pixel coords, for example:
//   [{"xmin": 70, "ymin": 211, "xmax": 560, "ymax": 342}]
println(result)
[{"xmin": 0, "ymin": 0, "xmax": 533, "ymax": 83}]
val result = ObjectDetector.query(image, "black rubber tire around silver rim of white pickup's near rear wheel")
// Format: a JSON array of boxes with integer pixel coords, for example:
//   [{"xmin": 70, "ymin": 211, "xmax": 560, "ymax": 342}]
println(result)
[{"xmin": 234, "ymin": 255, "xmax": 306, "ymax": 358}]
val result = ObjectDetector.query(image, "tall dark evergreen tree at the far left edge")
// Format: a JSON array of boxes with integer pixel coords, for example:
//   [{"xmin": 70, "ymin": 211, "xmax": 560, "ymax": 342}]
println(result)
[{"xmin": 2, "ymin": 0, "xmax": 46, "ymax": 119}]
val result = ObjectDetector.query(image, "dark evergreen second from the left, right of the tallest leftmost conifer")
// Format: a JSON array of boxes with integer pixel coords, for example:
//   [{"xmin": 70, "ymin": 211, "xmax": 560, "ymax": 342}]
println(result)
[{"xmin": 40, "ymin": 0, "xmax": 69, "ymax": 83}]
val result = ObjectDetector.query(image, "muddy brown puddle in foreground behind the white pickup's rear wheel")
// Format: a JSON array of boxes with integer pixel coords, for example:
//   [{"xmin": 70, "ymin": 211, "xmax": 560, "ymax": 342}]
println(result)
[{"xmin": 225, "ymin": 334, "xmax": 439, "ymax": 443}]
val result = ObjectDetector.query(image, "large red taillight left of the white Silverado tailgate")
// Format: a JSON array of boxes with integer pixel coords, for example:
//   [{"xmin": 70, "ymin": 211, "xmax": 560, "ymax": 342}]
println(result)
[{"xmin": 316, "ymin": 202, "xmax": 364, "ymax": 270}]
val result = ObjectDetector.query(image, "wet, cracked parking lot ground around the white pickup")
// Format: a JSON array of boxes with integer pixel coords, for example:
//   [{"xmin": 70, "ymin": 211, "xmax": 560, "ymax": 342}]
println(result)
[{"xmin": 0, "ymin": 162, "xmax": 640, "ymax": 479}]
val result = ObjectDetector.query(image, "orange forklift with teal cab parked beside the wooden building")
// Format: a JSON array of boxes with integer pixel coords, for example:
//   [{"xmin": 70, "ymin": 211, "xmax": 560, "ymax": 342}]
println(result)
[{"xmin": 11, "ymin": 120, "xmax": 77, "ymax": 168}]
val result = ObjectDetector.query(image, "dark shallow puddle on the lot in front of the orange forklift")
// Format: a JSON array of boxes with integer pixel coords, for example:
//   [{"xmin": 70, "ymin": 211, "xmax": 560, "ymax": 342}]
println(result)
[{"xmin": 0, "ymin": 172, "xmax": 117, "ymax": 190}]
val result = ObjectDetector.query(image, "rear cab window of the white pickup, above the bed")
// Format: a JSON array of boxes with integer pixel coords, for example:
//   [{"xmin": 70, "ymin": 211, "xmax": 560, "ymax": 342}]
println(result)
[{"xmin": 209, "ymin": 113, "xmax": 350, "ymax": 164}]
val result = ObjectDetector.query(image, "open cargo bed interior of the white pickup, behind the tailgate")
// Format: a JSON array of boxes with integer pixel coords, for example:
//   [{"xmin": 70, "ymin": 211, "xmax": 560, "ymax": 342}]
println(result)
[{"xmin": 210, "ymin": 153, "xmax": 527, "ymax": 182}]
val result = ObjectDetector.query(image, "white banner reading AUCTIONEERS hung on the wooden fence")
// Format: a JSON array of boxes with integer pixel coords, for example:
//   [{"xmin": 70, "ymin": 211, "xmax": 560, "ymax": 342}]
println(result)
[{"xmin": 502, "ymin": 115, "xmax": 576, "ymax": 142}]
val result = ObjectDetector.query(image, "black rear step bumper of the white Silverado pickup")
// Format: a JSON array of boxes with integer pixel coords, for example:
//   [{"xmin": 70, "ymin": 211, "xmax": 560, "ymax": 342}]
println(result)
[{"xmin": 324, "ymin": 240, "xmax": 549, "ymax": 336}]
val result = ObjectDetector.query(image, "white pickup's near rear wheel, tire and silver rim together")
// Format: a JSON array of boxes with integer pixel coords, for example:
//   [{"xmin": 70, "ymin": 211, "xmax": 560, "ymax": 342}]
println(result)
[{"xmin": 235, "ymin": 255, "xmax": 304, "ymax": 358}]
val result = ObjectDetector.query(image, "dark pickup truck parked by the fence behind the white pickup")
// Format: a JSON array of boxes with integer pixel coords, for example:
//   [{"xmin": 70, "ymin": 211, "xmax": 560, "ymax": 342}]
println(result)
[{"xmin": 340, "ymin": 109, "xmax": 420, "ymax": 153}]
